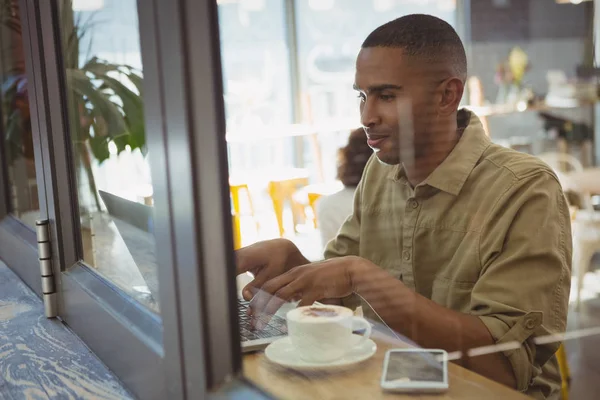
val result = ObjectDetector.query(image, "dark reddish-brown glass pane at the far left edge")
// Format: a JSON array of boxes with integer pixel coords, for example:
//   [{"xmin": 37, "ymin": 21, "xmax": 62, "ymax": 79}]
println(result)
[{"xmin": 0, "ymin": 1, "xmax": 40, "ymax": 228}]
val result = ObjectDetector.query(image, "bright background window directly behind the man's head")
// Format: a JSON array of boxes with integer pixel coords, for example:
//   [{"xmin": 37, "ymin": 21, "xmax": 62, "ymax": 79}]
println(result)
[{"xmin": 295, "ymin": 0, "xmax": 456, "ymax": 121}]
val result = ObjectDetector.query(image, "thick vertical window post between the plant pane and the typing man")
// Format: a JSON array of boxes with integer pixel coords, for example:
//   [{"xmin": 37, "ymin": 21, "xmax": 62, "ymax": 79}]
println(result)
[{"xmin": 149, "ymin": 0, "xmax": 270, "ymax": 399}]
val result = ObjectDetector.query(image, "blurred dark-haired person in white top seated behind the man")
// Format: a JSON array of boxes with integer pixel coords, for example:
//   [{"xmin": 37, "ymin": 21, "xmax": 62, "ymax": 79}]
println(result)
[{"xmin": 316, "ymin": 128, "xmax": 373, "ymax": 246}]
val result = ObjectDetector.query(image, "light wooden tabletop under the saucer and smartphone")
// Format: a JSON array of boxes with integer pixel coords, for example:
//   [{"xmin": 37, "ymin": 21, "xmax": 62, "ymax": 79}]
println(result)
[{"xmin": 243, "ymin": 334, "xmax": 528, "ymax": 400}]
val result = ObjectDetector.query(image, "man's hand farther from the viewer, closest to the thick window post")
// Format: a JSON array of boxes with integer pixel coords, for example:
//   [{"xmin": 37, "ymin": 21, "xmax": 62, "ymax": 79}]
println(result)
[{"xmin": 236, "ymin": 239, "xmax": 308, "ymax": 300}]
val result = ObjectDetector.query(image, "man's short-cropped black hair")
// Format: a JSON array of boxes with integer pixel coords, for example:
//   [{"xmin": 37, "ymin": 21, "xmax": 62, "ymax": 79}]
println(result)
[{"xmin": 362, "ymin": 14, "xmax": 467, "ymax": 82}]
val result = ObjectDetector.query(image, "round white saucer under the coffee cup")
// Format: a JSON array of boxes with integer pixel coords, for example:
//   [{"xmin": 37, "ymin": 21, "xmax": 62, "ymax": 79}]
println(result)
[{"xmin": 265, "ymin": 335, "xmax": 377, "ymax": 371}]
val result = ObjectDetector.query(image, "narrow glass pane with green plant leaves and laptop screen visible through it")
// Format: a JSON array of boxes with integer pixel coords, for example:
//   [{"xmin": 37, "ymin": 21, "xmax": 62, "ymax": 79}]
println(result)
[{"xmin": 60, "ymin": 0, "xmax": 159, "ymax": 312}]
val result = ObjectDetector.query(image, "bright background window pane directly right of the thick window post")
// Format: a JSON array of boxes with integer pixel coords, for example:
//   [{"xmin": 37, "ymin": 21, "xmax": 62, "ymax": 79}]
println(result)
[{"xmin": 218, "ymin": 0, "xmax": 292, "ymax": 130}]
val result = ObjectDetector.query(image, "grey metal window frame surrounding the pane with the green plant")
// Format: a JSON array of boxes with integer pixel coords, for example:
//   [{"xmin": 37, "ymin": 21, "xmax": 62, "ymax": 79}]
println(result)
[{"xmin": 11, "ymin": 0, "xmax": 266, "ymax": 399}]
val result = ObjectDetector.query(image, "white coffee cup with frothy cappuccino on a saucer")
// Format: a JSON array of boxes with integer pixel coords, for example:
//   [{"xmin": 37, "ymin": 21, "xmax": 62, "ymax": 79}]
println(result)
[{"xmin": 287, "ymin": 305, "xmax": 371, "ymax": 363}]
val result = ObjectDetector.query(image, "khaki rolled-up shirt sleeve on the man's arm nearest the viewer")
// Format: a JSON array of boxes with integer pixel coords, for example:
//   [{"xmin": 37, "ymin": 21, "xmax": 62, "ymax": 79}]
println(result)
[{"xmin": 470, "ymin": 170, "xmax": 572, "ymax": 391}]
